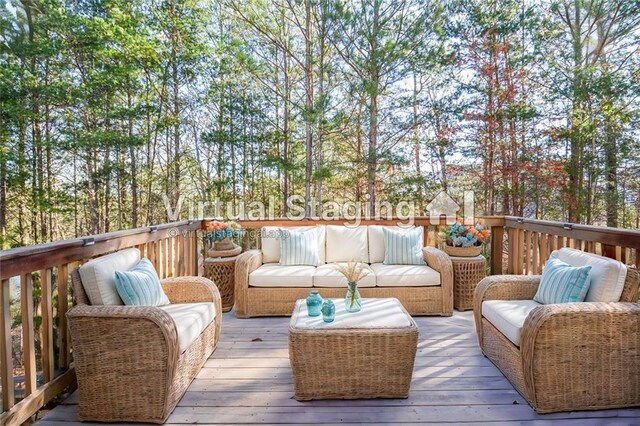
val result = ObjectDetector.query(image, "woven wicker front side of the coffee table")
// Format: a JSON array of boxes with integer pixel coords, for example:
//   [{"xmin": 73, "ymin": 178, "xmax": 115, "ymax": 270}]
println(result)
[{"xmin": 289, "ymin": 302, "xmax": 418, "ymax": 401}]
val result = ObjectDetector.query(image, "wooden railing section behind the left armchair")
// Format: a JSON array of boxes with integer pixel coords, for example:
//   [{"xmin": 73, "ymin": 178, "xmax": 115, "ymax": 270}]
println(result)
[{"xmin": 0, "ymin": 221, "xmax": 201, "ymax": 425}]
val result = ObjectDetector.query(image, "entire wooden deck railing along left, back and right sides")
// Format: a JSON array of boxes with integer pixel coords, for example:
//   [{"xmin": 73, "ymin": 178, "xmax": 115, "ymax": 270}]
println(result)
[{"xmin": 0, "ymin": 217, "xmax": 640, "ymax": 425}]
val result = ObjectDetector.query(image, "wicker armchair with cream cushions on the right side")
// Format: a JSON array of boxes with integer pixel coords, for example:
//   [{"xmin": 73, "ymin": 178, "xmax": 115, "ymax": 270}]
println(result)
[{"xmin": 474, "ymin": 248, "xmax": 640, "ymax": 413}]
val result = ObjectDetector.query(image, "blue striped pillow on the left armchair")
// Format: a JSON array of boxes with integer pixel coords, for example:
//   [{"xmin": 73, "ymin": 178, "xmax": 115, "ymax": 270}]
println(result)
[{"xmin": 116, "ymin": 258, "xmax": 169, "ymax": 306}]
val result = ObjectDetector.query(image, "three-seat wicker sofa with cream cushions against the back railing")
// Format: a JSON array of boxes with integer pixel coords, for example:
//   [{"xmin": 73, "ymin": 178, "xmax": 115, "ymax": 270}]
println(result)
[{"xmin": 235, "ymin": 225, "xmax": 453, "ymax": 318}]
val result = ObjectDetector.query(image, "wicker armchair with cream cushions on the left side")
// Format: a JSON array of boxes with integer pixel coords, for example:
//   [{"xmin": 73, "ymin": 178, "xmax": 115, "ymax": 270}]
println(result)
[{"xmin": 67, "ymin": 249, "xmax": 222, "ymax": 423}]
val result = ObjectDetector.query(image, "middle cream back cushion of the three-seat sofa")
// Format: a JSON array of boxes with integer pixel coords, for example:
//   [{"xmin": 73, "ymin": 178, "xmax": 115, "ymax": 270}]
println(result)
[{"xmin": 327, "ymin": 225, "xmax": 369, "ymax": 263}]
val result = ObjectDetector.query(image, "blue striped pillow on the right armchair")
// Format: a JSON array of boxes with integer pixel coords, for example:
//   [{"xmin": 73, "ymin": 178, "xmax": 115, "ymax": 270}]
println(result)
[{"xmin": 533, "ymin": 256, "xmax": 591, "ymax": 304}]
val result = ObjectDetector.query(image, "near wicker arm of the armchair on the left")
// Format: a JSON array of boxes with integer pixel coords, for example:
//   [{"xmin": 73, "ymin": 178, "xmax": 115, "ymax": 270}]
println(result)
[{"xmin": 67, "ymin": 305, "xmax": 180, "ymax": 421}]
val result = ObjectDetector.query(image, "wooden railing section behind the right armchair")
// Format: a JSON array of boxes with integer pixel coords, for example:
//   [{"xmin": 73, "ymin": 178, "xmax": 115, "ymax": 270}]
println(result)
[{"xmin": 484, "ymin": 216, "xmax": 640, "ymax": 275}]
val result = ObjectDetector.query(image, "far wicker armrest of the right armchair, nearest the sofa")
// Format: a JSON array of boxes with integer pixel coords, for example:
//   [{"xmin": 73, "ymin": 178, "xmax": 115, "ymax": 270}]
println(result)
[{"xmin": 473, "ymin": 275, "xmax": 540, "ymax": 346}]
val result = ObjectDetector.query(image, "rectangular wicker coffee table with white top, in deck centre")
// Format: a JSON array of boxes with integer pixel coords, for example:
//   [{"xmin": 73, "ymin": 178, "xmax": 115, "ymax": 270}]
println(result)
[{"xmin": 289, "ymin": 298, "xmax": 418, "ymax": 401}]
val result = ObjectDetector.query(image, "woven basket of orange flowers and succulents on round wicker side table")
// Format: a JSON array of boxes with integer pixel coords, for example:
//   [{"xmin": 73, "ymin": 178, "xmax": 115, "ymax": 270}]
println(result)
[{"xmin": 440, "ymin": 218, "xmax": 491, "ymax": 257}]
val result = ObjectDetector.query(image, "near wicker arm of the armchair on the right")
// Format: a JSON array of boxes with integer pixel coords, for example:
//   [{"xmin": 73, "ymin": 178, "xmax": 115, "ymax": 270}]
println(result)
[{"xmin": 520, "ymin": 302, "xmax": 640, "ymax": 408}]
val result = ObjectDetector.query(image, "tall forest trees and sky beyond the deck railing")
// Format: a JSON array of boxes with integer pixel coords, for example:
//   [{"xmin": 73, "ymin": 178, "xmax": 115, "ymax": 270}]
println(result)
[{"xmin": 0, "ymin": 0, "xmax": 640, "ymax": 249}]
